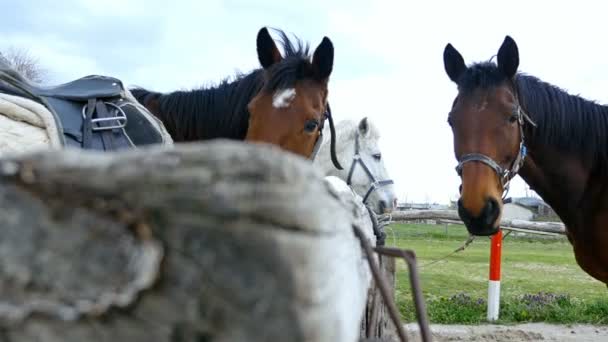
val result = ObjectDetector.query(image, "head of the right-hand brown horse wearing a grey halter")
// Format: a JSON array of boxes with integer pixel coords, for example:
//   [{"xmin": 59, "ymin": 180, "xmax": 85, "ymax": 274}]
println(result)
[{"xmin": 443, "ymin": 36, "xmax": 527, "ymax": 235}]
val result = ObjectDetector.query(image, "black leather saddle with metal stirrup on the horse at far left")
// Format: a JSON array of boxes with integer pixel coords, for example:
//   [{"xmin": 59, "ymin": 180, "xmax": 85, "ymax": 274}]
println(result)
[{"xmin": 0, "ymin": 61, "xmax": 164, "ymax": 151}]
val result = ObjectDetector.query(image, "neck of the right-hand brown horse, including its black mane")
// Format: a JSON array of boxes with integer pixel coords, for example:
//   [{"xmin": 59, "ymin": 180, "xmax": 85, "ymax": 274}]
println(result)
[{"xmin": 517, "ymin": 75, "xmax": 608, "ymax": 225}]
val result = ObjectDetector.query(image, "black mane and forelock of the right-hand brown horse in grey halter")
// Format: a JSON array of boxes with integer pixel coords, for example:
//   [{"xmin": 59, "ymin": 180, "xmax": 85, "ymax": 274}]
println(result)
[{"xmin": 458, "ymin": 62, "xmax": 608, "ymax": 167}]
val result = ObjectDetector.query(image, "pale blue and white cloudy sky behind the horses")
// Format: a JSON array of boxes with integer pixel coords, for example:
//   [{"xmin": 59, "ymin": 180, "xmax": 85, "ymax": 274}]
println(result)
[{"xmin": 0, "ymin": 0, "xmax": 608, "ymax": 203}]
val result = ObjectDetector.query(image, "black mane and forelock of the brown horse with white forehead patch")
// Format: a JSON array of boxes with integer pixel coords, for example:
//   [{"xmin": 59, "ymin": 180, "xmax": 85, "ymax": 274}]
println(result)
[{"xmin": 131, "ymin": 30, "xmax": 314, "ymax": 141}]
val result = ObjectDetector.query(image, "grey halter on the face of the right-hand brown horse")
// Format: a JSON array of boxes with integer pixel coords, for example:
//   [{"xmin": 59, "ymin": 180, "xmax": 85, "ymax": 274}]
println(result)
[{"xmin": 456, "ymin": 96, "xmax": 536, "ymax": 200}]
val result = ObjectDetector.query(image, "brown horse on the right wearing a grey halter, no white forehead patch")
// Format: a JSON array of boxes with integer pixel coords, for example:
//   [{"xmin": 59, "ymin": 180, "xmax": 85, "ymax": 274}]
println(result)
[{"xmin": 443, "ymin": 36, "xmax": 608, "ymax": 284}]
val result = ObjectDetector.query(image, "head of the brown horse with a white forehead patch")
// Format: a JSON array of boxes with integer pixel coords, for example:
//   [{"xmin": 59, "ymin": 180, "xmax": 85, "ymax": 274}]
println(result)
[{"xmin": 245, "ymin": 28, "xmax": 339, "ymax": 167}]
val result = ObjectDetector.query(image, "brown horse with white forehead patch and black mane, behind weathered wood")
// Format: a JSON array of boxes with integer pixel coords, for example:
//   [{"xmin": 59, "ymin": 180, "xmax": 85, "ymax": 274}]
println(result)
[{"xmin": 131, "ymin": 28, "xmax": 341, "ymax": 169}]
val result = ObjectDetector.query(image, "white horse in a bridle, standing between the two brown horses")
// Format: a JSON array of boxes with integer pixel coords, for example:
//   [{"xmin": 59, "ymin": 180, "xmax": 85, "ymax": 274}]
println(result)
[{"xmin": 314, "ymin": 118, "xmax": 397, "ymax": 214}]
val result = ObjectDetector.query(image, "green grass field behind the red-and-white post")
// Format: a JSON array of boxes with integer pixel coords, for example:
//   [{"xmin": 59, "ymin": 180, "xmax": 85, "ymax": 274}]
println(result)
[{"xmin": 387, "ymin": 224, "xmax": 608, "ymax": 324}]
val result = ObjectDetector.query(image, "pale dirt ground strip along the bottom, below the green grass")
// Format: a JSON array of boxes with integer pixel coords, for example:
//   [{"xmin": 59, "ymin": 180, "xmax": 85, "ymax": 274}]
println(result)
[{"xmin": 405, "ymin": 323, "xmax": 608, "ymax": 342}]
